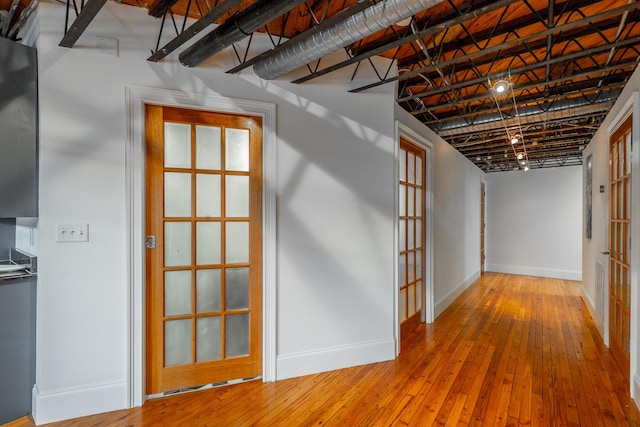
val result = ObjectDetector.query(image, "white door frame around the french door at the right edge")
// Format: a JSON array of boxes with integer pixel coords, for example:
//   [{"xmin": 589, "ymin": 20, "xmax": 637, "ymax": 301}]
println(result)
[{"xmin": 603, "ymin": 91, "xmax": 640, "ymax": 404}]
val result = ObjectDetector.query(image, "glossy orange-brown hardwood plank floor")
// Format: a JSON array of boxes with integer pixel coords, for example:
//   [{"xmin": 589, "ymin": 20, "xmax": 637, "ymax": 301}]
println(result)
[{"xmin": 9, "ymin": 273, "xmax": 640, "ymax": 427}]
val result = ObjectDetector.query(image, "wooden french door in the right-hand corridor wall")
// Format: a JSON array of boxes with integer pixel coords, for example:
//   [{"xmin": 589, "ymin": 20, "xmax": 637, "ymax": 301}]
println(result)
[{"xmin": 609, "ymin": 117, "xmax": 632, "ymax": 379}]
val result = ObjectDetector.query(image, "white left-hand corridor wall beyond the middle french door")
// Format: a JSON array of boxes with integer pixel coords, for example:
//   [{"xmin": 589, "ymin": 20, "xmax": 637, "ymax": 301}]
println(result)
[{"xmin": 395, "ymin": 106, "xmax": 485, "ymax": 316}]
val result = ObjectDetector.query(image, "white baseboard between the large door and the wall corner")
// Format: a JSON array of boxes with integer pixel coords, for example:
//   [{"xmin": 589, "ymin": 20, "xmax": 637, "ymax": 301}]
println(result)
[{"xmin": 276, "ymin": 338, "xmax": 395, "ymax": 380}]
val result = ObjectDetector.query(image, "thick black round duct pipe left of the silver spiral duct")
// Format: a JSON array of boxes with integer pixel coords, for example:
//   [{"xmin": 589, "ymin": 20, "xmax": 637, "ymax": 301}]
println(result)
[{"xmin": 179, "ymin": 0, "xmax": 305, "ymax": 67}]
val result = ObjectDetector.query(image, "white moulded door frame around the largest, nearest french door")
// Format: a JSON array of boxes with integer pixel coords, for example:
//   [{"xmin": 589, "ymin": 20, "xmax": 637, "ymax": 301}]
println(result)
[{"xmin": 125, "ymin": 87, "xmax": 277, "ymax": 407}]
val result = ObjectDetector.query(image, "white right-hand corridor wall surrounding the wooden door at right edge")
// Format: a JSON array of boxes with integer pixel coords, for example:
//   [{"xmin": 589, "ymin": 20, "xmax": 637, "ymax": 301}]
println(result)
[{"xmin": 582, "ymin": 62, "xmax": 640, "ymax": 405}]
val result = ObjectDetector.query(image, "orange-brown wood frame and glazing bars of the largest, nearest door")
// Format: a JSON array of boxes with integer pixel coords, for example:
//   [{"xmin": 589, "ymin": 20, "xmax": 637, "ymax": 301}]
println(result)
[{"xmin": 147, "ymin": 106, "xmax": 263, "ymax": 394}]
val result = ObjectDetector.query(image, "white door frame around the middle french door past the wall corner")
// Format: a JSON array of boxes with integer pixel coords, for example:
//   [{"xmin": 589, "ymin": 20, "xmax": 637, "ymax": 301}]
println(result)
[{"xmin": 393, "ymin": 120, "xmax": 435, "ymax": 356}]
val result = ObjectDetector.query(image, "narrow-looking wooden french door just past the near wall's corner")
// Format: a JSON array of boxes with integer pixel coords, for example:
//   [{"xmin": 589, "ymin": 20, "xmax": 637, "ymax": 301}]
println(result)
[{"xmin": 398, "ymin": 138, "xmax": 425, "ymax": 330}]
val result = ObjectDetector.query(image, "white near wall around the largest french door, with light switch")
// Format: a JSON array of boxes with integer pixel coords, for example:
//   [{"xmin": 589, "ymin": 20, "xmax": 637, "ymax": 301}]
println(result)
[{"xmin": 28, "ymin": 1, "xmax": 395, "ymax": 423}]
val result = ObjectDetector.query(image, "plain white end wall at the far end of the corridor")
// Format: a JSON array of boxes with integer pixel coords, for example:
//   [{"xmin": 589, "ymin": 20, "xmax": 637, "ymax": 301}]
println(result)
[{"xmin": 486, "ymin": 166, "xmax": 582, "ymax": 280}]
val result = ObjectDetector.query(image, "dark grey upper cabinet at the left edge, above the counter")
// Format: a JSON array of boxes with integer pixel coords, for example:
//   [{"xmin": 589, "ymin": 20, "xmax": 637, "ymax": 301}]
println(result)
[{"xmin": 0, "ymin": 37, "xmax": 38, "ymax": 218}]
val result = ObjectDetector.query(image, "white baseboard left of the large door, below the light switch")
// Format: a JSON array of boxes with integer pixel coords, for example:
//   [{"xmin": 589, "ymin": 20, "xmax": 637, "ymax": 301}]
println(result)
[{"xmin": 32, "ymin": 382, "xmax": 128, "ymax": 425}]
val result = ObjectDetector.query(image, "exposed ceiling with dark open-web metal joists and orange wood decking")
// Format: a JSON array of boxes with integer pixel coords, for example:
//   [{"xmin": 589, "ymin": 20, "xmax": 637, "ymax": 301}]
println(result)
[{"xmin": 6, "ymin": 0, "xmax": 640, "ymax": 172}]
